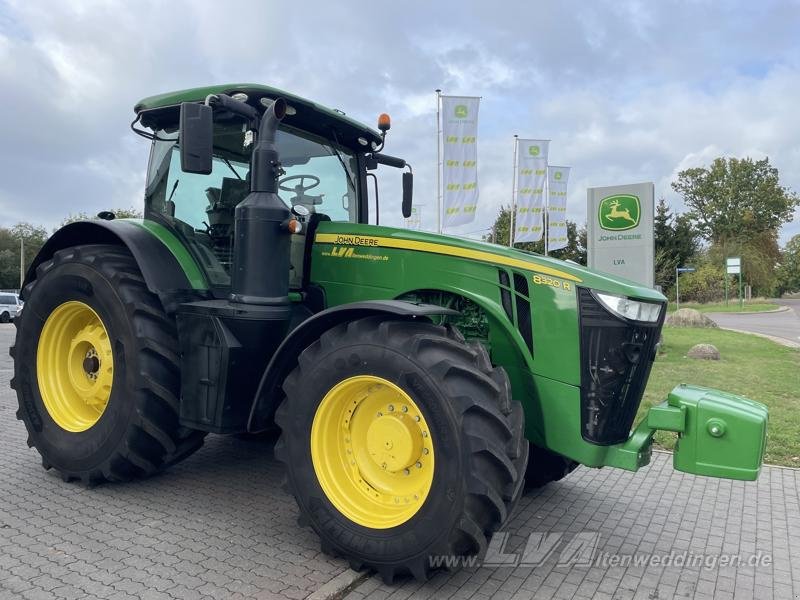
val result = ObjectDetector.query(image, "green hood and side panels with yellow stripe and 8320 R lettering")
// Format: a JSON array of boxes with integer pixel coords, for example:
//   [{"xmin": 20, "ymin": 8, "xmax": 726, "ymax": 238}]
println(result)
[{"xmin": 311, "ymin": 222, "xmax": 665, "ymax": 466}]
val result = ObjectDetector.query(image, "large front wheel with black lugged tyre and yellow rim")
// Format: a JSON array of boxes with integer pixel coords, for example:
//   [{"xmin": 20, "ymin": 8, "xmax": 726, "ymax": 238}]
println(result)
[{"xmin": 275, "ymin": 317, "xmax": 528, "ymax": 582}]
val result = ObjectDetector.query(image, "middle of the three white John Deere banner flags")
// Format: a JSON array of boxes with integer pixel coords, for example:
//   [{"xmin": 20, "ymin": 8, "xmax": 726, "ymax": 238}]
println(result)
[{"xmin": 514, "ymin": 140, "xmax": 550, "ymax": 243}]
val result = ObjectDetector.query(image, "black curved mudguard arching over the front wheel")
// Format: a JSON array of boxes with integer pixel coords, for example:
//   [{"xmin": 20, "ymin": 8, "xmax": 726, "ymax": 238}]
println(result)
[{"xmin": 247, "ymin": 300, "xmax": 459, "ymax": 433}]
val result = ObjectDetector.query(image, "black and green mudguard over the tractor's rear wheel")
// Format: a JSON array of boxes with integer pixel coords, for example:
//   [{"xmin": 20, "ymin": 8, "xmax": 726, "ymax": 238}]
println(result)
[{"xmin": 22, "ymin": 219, "xmax": 208, "ymax": 312}]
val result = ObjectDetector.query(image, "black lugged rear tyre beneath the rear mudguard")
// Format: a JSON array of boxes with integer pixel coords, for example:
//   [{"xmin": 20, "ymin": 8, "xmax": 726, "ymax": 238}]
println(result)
[{"xmin": 11, "ymin": 245, "xmax": 205, "ymax": 484}]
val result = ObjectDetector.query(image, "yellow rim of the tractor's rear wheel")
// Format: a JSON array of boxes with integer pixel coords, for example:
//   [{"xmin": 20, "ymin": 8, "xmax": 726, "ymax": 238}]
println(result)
[{"xmin": 36, "ymin": 300, "xmax": 114, "ymax": 432}]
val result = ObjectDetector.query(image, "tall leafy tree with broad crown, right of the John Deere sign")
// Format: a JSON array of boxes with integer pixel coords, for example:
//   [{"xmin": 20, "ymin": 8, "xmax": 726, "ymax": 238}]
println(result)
[{"xmin": 672, "ymin": 158, "xmax": 800, "ymax": 256}]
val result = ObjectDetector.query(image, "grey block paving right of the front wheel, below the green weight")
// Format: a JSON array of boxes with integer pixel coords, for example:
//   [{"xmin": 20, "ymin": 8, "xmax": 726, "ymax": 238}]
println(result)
[{"xmin": 346, "ymin": 452, "xmax": 800, "ymax": 600}]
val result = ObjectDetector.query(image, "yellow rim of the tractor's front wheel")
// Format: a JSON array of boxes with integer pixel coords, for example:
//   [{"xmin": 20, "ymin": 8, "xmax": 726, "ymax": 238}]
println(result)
[{"xmin": 311, "ymin": 375, "xmax": 434, "ymax": 529}]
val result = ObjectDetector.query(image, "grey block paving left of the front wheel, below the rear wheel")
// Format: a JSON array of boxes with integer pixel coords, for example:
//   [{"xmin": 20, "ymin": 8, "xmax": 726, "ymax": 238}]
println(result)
[{"xmin": 0, "ymin": 325, "xmax": 347, "ymax": 600}]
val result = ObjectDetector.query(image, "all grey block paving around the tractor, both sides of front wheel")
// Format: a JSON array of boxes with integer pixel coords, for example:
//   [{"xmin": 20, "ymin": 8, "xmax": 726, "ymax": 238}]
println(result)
[{"xmin": 0, "ymin": 325, "xmax": 800, "ymax": 600}]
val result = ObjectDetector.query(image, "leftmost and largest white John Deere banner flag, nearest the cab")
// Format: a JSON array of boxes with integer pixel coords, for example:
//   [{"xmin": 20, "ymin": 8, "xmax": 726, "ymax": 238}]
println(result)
[{"xmin": 442, "ymin": 96, "xmax": 480, "ymax": 227}]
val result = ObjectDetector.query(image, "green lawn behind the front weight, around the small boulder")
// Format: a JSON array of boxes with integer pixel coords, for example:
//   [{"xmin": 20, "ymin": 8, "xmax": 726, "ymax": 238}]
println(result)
[{"xmin": 636, "ymin": 327, "xmax": 800, "ymax": 467}]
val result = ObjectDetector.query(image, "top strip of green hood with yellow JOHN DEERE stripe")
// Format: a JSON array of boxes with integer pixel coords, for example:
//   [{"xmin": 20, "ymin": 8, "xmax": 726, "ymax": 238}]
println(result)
[{"xmin": 316, "ymin": 223, "xmax": 667, "ymax": 302}]
